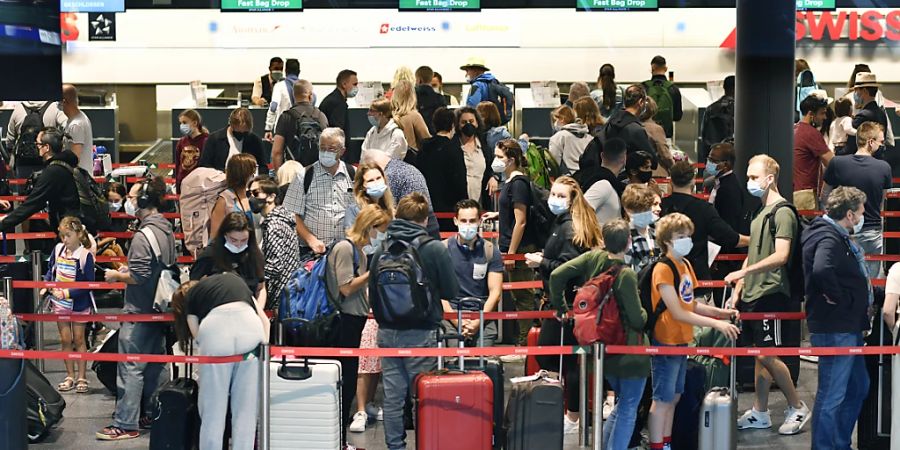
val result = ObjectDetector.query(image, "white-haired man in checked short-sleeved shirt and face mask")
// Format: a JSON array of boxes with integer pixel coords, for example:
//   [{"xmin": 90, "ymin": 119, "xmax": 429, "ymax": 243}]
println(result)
[{"xmin": 284, "ymin": 128, "xmax": 356, "ymax": 256}]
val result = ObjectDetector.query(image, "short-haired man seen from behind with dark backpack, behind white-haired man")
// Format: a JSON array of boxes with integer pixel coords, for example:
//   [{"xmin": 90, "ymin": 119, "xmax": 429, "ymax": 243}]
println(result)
[{"xmin": 272, "ymin": 80, "xmax": 328, "ymax": 170}]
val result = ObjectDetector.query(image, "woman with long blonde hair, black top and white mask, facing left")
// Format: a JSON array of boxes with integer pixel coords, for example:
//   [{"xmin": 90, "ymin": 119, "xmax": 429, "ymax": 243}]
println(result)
[{"xmin": 525, "ymin": 176, "xmax": 603, "ymax": 433}]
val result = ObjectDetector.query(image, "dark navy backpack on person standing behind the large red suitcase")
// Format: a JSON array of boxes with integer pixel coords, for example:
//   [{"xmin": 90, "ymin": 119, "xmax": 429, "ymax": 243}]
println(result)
[{"xmin": 369, "ymin": 236, "xmax": 440, "ymax": 328}]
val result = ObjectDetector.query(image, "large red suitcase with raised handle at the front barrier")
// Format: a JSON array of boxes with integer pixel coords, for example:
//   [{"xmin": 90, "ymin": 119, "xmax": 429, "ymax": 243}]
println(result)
[{"xmin": 415, "ymin": 299, "xmax": 494, "ymax": 450}]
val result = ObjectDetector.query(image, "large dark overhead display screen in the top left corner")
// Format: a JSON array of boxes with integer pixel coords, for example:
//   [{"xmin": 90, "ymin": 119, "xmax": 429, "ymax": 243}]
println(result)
[{"xmin": 0, "ymin": 0, "xmax": 62, "ymax": 100}]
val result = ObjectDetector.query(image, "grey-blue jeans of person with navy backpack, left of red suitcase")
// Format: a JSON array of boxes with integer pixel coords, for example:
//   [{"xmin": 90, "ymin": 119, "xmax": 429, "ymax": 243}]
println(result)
[{"xmin": 378, "ymin": 328, "xmax": 437, "ymax": 450}]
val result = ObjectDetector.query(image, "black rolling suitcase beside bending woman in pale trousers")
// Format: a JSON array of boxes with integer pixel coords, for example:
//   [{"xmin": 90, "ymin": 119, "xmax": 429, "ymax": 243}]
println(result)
[{"xmin": 150, "ymin": 342, "xmax": 200, "ymax": 450}]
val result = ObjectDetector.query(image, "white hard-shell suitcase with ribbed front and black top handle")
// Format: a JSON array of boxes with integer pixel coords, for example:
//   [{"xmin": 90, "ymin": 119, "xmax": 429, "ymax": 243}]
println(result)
[{"xmin": 269, "ymin": 359, "xmax": 341, "ymax": 450}]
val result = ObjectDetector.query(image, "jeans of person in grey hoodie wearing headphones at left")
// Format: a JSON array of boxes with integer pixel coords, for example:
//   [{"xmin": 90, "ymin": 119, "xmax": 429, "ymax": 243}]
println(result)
[{"xmin": 113, "ymin": 322, "xmax": 169, "ymax": 430}]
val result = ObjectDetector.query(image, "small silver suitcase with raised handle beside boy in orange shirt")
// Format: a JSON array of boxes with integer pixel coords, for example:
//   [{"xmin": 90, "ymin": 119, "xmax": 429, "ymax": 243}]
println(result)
[{"xmin": 697, "ymin": 328, "xmax": 737, "ymax": 450}]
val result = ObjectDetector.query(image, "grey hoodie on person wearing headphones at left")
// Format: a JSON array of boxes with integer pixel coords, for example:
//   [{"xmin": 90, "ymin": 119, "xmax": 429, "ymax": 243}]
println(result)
[{"xmin": 123, "ymin": 211, "xmax": 176, "ymax": 314}]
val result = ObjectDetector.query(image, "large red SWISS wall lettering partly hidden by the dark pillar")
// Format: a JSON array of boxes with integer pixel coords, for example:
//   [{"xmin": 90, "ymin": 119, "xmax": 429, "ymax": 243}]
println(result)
[{"xmin": 719, "ymin": 10, "xmax": 900, "ymax": 50}]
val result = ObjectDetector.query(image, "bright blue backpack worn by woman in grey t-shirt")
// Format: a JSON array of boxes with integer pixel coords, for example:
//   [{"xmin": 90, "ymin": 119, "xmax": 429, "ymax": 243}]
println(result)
[{"xmin": 278, "ymin": 240, "xmax": 359, "ymax": 347}]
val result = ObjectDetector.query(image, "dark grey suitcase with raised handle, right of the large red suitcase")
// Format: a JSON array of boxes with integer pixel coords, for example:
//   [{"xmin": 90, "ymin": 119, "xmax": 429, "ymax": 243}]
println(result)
[{"xmin": 504, "ymin": 326, "xmax": 565, "ymax": 450}]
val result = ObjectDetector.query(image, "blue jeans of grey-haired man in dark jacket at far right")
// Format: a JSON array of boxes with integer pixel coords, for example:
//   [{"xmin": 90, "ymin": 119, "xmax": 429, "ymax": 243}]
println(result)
[{"xmin": 809, "ymin": 333, "xmax": 869, "ymax": 450}]
